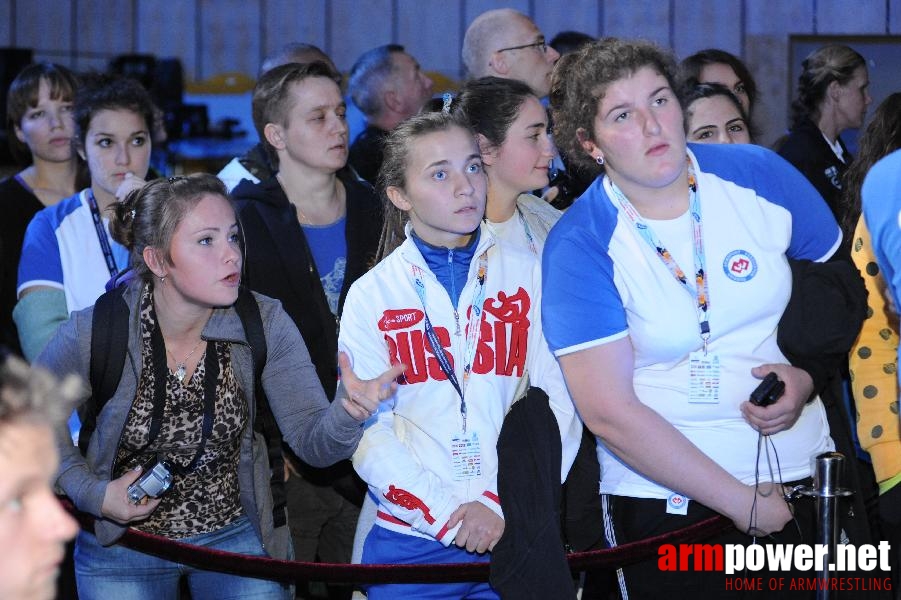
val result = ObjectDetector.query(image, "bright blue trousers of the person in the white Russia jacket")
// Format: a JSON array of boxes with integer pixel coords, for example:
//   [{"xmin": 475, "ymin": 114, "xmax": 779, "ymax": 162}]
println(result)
[{"xmin": 363, "ymin": 525, "xmax": 500, "ymax": 600}]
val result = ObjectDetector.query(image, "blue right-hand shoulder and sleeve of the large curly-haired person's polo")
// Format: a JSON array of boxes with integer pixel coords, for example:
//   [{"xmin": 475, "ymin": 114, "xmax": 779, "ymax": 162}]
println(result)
[{"xmin": 690, "ymin": 144, "xmax": 842, "ymax": 262}]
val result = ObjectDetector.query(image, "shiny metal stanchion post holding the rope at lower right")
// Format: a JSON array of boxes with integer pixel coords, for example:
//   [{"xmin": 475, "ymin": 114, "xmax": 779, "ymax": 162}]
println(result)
[{"xmin": 797, "ymin": 452, "xmax": 854, "ymax": 600}]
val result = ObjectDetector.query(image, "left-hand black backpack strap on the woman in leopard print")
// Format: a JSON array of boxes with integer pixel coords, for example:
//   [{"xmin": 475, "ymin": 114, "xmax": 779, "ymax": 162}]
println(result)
[{"xmin": 78, "ymin": 286, "xmax": 128, "ymax": 454}]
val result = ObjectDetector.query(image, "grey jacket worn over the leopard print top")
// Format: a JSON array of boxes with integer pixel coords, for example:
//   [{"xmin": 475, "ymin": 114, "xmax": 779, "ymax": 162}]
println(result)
[{"xmin": 37, "ymin": 283, "xmax": 363, "ymax": 559}]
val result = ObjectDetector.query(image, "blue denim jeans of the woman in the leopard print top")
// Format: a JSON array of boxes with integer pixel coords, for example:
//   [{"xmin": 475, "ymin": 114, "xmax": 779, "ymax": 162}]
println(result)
[{"xmin": 75, "ymin": 517, "xmax": 293, "ymax": 600}]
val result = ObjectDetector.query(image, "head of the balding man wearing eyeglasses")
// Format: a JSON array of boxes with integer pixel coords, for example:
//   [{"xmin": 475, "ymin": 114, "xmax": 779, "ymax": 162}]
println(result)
[{"xmin": 463, "ymin": 8, "xmax": 560, "ymax": 98}]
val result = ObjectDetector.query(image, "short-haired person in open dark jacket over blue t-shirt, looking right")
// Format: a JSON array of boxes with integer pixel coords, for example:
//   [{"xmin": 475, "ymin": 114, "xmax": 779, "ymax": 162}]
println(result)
[{"xmin": 233, "ymin": 63, "xmax": 382, "ymax": 598}]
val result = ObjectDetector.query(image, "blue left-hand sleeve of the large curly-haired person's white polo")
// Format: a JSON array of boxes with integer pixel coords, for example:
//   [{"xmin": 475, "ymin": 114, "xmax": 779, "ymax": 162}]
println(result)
[{"xmin": 541, "ymin": 178, "xmax": 628, "ymax": 356}]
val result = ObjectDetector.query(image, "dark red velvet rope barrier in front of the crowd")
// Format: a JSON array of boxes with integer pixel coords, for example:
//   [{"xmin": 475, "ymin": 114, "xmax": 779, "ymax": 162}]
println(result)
[{"xmin": 61, "ymin": 499, "xmax": 732, "ymax": 584}]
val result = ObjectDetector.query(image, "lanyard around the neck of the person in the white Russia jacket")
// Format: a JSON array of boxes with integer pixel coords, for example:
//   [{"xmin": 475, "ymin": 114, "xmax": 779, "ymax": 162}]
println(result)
[{"xmin": 412, "ymin": 251, "xmax": 488, "ymax": 433}]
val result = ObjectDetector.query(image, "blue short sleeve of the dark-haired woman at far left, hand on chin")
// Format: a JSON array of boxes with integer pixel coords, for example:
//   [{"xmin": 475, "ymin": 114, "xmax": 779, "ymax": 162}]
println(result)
[{"xmin": 16, "ymin": 205, "xmax": 65, "ymax": 294}]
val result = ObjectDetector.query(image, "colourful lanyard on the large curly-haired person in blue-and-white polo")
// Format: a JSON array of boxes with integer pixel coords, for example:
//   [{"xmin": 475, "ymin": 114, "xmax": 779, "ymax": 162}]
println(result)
[{"xmin": 605, "ymin": 158, "xmax": 710, "ymax": 354}]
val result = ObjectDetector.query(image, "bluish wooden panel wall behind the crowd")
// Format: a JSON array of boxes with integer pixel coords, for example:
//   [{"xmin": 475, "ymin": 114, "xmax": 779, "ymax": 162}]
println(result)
[{"xmin": 0, "ymin": 0, "xmax": 901, "ymax": 143}]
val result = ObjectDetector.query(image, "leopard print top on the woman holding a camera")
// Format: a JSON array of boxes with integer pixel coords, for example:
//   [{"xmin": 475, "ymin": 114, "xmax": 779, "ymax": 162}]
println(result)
[{"xmin": 114, "ymin": 286, "xmax": 247, "ymax": 539}]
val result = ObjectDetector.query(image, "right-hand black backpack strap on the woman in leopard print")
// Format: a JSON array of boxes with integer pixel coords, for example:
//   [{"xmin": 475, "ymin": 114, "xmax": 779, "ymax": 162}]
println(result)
[{"xmin": 235, "ymin": 287, "xmax": 288, "ymax": 527}]
